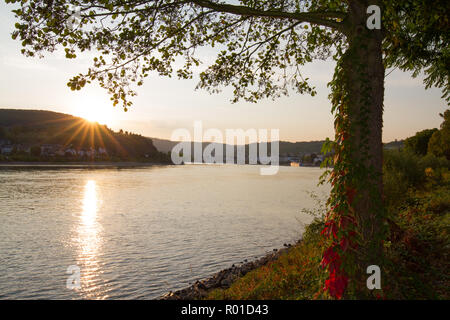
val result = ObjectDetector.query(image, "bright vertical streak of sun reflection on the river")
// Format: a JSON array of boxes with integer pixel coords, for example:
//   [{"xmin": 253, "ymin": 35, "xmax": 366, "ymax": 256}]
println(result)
[{"xmin": 76, "ymin": 180, "xmax": 107, "ymax": 299}]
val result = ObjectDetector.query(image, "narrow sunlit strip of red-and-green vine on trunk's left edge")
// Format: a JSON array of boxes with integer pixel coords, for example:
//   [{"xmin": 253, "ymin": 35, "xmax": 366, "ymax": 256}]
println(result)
[{"xmin": 321, "ymin": 48, "xmax": 358, "ymax": 299}]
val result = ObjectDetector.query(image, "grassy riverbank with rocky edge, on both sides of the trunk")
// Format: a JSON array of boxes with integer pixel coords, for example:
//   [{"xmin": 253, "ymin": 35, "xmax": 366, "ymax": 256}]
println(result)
[{"xmin": 161, "ymin": 177, "xmax": 450, "ymax": 300}]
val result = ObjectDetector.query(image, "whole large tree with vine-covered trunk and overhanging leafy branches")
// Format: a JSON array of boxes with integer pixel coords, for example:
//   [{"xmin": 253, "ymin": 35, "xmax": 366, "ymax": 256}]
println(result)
[{"xmin": 6, "ymin": 0, "xmax": 450, "ymax": 298}]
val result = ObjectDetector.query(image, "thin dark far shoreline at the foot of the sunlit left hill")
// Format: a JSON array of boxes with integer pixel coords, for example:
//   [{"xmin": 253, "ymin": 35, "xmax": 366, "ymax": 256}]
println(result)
[{"xmin": 0, "ymin": 161, "xmax": 170, "ymax": 169}]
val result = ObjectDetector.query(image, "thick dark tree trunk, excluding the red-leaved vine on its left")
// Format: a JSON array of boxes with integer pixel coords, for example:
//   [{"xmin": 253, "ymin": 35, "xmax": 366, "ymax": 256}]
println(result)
[{"xmin": 344, "ymin": 1, "xmax": 385, "ymax": 274}]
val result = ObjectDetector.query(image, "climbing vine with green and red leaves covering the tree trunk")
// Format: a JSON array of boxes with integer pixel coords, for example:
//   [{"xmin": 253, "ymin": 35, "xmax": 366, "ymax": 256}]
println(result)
[{"xmin": 321, "ymin": 31, "xmax": 384, "ymax": 299}]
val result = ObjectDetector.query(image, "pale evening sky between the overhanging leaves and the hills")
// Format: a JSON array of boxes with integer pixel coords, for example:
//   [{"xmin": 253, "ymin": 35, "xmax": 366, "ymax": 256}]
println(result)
[{"xmin": 0, "ymin": 1, "xmax": 447, "ymax": 142}]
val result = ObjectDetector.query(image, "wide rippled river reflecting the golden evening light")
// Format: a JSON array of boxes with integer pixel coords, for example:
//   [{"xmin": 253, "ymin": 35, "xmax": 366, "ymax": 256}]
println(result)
[{"xmin": 0, "ymin": 165, "xmax": 328, "ymax": 299}]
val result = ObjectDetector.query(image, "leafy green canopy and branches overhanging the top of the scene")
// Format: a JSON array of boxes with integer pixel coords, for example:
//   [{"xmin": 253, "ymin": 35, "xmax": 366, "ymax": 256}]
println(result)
[{"xmin": 6, "ymin": 0, "xmax": 450, "ymax": 110}]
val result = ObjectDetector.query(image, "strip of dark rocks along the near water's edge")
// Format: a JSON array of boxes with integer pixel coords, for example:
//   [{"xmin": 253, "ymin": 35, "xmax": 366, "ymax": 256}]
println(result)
[{"xmin": 158, "ymin": 240, "xmax": 300, "ymax": 300}]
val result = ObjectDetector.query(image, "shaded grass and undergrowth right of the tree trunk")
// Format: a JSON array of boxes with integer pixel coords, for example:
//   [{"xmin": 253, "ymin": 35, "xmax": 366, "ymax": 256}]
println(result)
[{"xmin": 386, "ymin": 183, "xmax": 450, "ymax": 299}]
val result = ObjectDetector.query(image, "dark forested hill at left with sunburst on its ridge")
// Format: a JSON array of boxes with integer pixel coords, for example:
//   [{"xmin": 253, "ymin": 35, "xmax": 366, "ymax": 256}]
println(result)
[{"xmin": 0, "ymin": 109, "xmax": 168, "ymax": 160}]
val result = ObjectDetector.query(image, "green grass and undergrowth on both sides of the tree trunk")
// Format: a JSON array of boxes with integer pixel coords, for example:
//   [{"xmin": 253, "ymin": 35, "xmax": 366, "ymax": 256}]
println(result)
[{"xmin": 208, "ymin": 154, "xmax": 450, "ymax": 300}]
